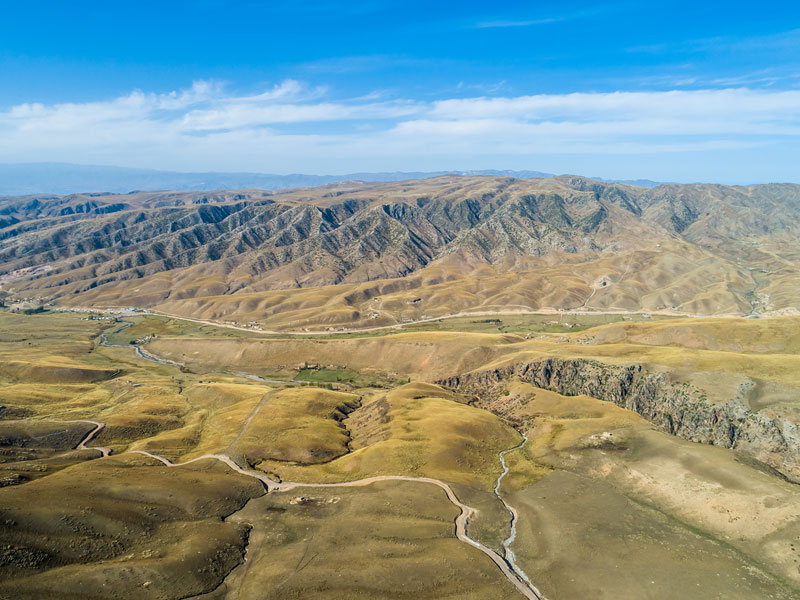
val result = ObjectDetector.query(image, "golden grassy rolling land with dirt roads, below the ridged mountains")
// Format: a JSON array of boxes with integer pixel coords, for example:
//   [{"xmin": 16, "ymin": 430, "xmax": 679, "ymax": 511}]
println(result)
[{"xmin": 0, "ymin": 313, "xmax": 800, "ymax": 600}]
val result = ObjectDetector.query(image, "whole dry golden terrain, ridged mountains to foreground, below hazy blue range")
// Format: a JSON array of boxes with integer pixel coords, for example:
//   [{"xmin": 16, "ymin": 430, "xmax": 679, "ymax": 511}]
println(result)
[{"xmin": 0, "ymin": 175, "xmax": 800, "ymax": 600}]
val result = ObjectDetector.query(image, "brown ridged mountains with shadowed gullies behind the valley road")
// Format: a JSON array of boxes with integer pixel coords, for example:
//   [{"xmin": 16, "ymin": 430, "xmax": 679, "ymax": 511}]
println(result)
[{"xmin": 0, "ymin": 175, "xmax": 800, "ymax": 327}]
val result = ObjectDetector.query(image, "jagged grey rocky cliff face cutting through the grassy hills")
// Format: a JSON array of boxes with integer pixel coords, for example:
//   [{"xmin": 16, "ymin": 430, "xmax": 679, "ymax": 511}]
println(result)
[{"xmin": 439, "ymin": 359, "xmax": 800, "ymax": 483}]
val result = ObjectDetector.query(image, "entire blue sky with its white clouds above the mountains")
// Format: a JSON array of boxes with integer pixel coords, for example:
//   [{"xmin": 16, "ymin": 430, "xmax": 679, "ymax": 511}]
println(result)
[{"xmin": 0, "ymin": 0, "xmax": 800, "ymax": 183}]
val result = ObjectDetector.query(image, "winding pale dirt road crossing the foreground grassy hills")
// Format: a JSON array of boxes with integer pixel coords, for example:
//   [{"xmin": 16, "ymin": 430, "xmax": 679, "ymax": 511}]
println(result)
[{"xmin": 75, "ymin": 420, "xmax": 545, "ymax": 600}]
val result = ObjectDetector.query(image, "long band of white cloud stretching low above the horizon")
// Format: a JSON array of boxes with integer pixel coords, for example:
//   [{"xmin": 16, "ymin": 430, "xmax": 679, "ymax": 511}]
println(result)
[{"xmin": 0, "ymin": 80, "xmax": 800, "ymax": 172}]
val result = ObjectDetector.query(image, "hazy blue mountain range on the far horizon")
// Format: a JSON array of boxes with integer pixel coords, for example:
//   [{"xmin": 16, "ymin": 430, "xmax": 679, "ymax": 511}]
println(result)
[{"xmin": 0, "ymin": 163, "xmax": 658, "ymax": 196}]
